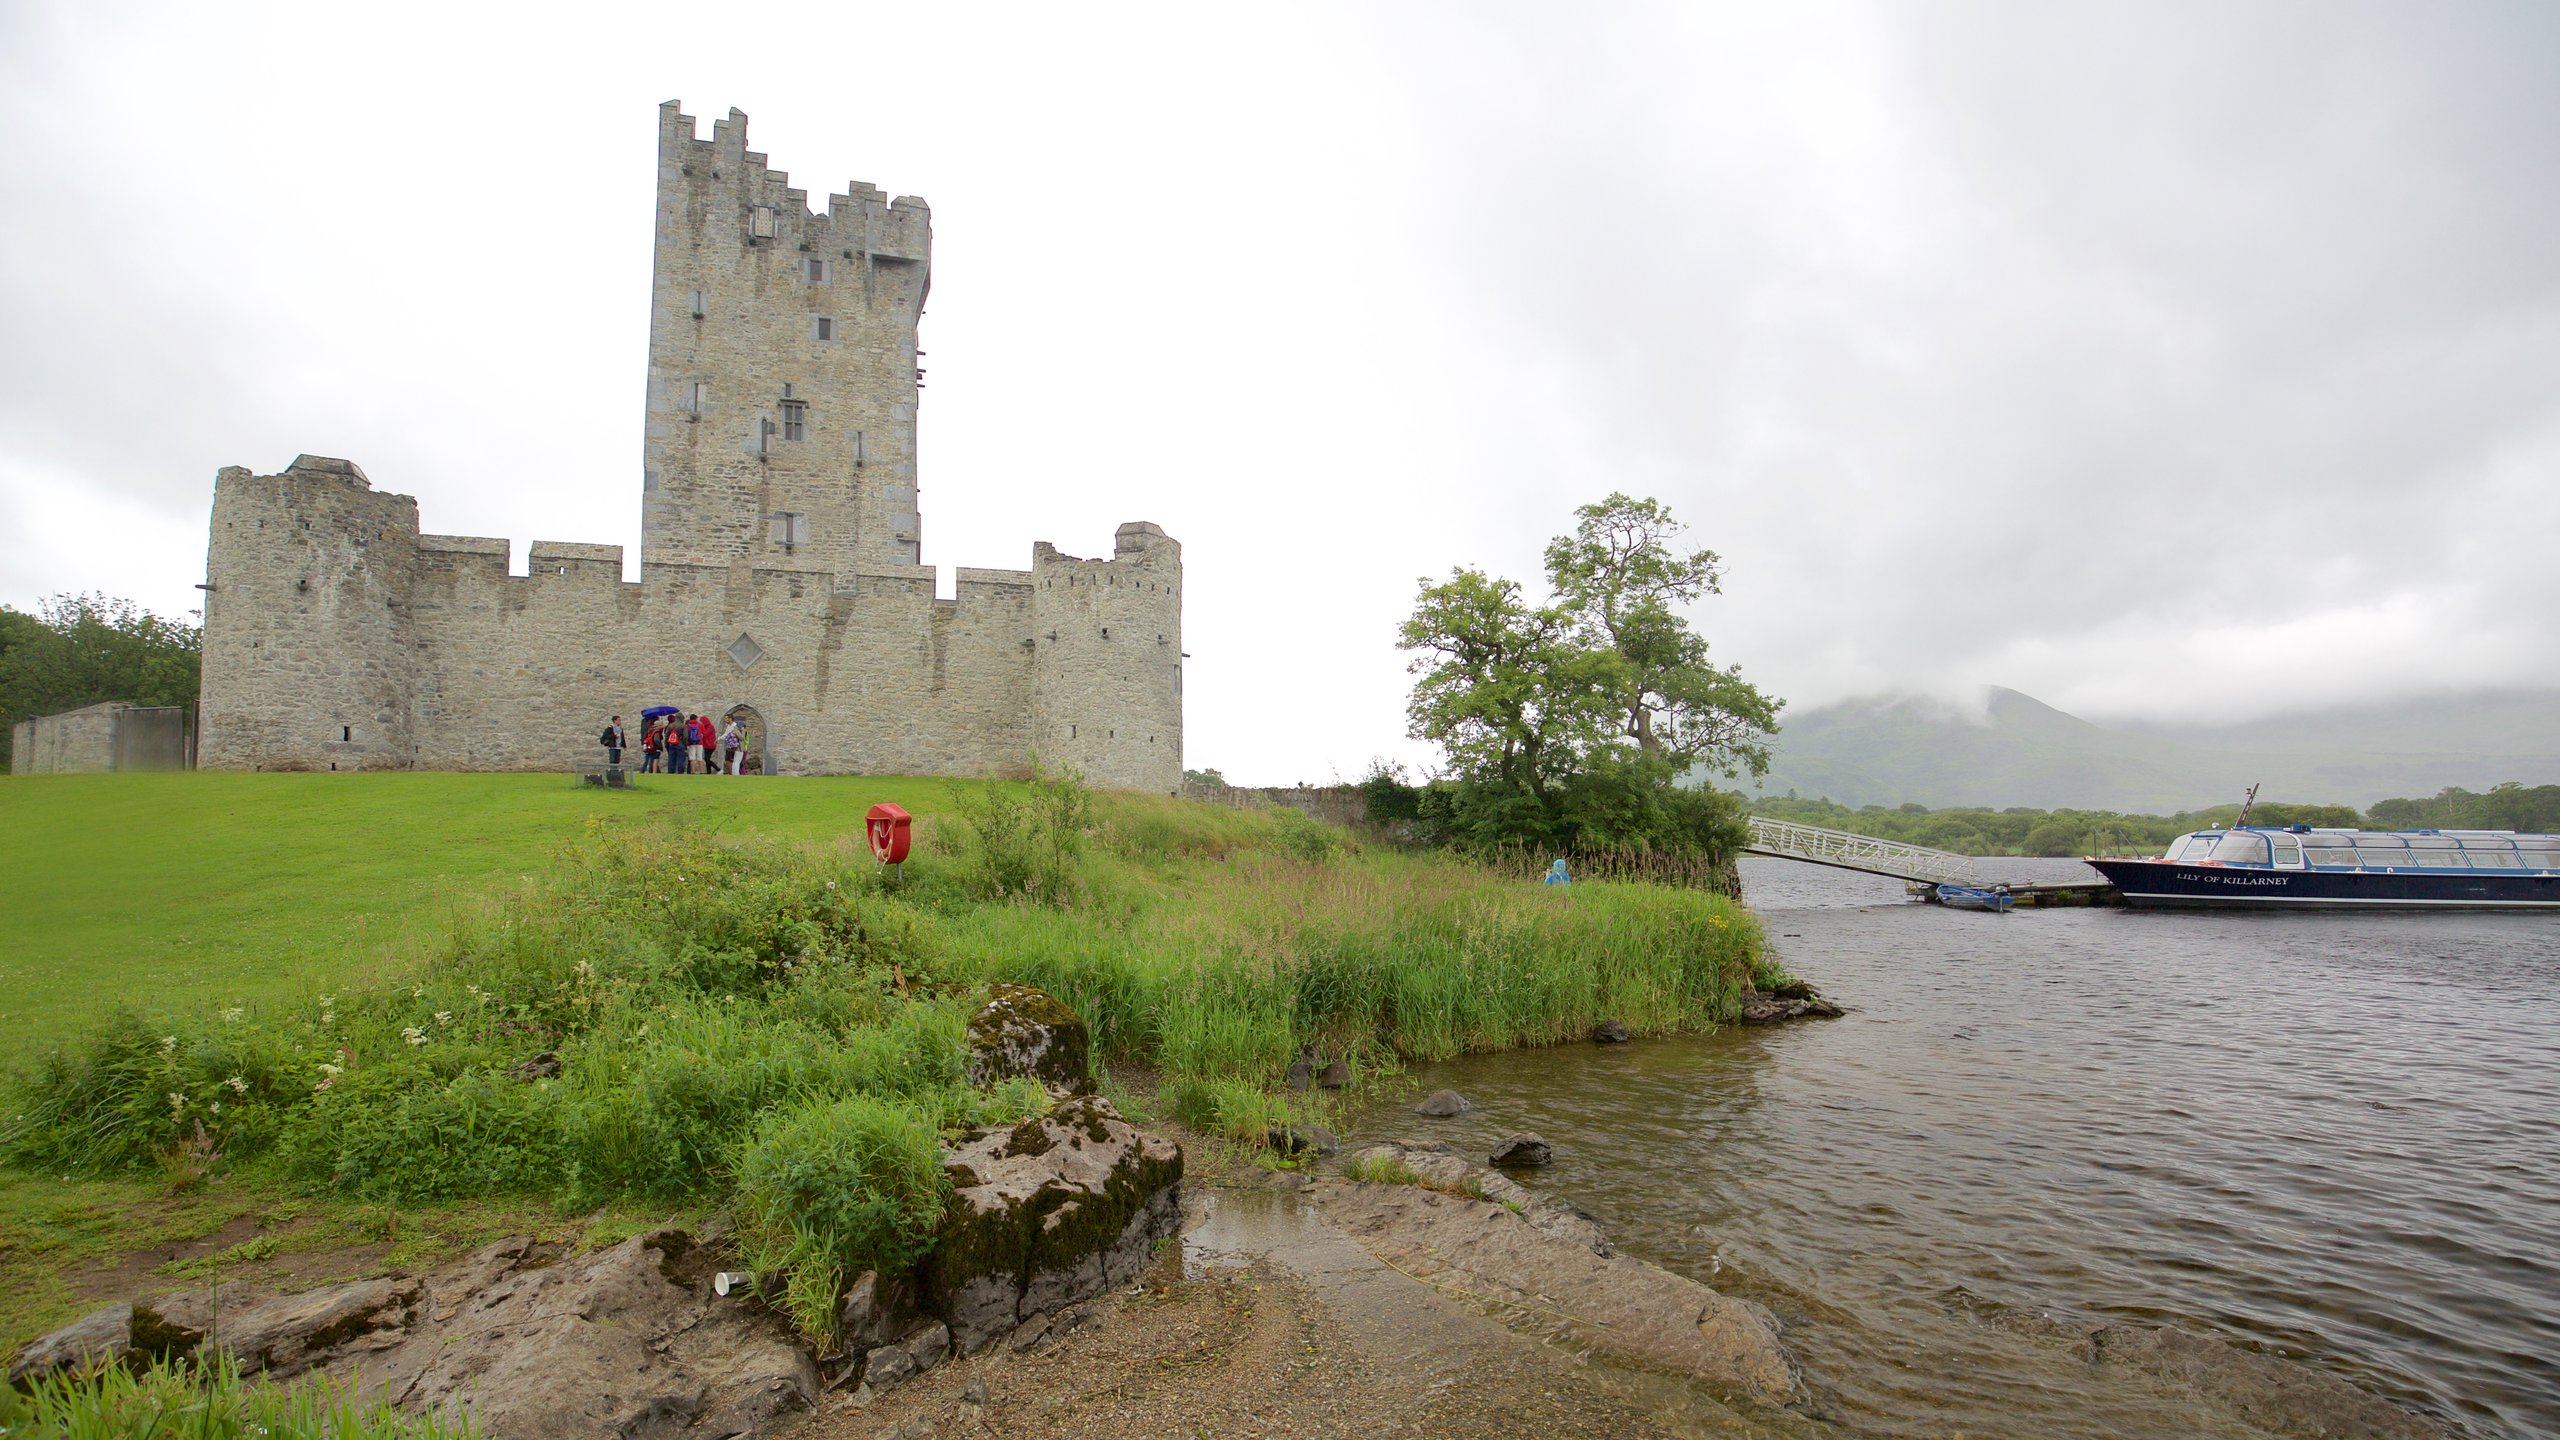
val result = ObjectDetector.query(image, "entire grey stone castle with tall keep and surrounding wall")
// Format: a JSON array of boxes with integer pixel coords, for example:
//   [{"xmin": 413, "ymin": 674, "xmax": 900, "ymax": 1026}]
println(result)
[{"xmin": 197, "ymin": 100, "xmax": 1183, "ymax": 792}]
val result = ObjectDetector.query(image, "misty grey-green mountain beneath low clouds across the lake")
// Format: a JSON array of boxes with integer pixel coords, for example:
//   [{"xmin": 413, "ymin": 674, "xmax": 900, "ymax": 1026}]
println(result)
[{"xmin": 1759, "ymin": 687, "xmax": 2560, "ymax": 815}]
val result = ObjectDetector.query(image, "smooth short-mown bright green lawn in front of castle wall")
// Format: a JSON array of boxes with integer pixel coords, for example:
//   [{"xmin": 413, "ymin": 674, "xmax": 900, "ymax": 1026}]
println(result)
[{"xmin": 0, "ymin": 774, "xmax": 947, "ymax": 1053}]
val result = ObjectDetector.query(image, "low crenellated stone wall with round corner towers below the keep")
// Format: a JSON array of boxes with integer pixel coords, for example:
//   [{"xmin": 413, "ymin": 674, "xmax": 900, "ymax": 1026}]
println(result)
[{"xmin": 202, "ymin": 456, "xmax": 1183, "ymax": 794}]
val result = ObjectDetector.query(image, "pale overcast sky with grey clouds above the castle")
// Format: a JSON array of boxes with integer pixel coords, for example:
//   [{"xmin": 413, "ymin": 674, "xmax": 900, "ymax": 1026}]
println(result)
[{"xmin": 0, "ymin": 0, "xmax": 2560, "ymax": 784}]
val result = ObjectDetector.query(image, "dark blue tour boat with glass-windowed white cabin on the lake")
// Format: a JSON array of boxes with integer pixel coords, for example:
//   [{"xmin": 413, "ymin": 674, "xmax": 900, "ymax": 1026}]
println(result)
[{"xmin": 2089, "ymin": 825, "xmax": 2560, "ymax": 910}]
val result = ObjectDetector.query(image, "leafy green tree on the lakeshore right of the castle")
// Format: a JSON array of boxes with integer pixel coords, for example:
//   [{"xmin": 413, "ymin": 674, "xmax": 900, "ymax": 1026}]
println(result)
[{"xmin": 1398, "ymin": 495, "xmax": 1779, "ymax": 851}]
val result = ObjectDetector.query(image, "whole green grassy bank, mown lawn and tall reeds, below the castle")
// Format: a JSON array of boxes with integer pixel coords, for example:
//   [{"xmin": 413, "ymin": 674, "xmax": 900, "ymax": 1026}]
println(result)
[{"xmin": 0, "ymin": 774, "xmax": 1772, "ymax": 1350}]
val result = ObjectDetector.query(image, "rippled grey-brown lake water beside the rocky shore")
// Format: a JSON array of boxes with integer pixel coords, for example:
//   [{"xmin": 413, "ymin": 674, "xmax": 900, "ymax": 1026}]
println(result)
[{"xmin": 1357, "ymin": 861, "xmax": 2560, "ymax": 1440}]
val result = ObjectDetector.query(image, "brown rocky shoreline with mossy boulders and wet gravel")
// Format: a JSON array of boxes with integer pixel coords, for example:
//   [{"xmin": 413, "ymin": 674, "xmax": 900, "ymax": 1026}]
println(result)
[{"xmin": 10, "ymin": 986, "xmax": 2437, "ymax": 1440}]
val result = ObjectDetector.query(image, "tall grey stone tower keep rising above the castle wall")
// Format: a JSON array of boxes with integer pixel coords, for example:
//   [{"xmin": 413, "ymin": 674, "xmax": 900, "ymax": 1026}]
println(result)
[{"xmin": 640, "ymin": 102, "xmax": 932, "ymax": 574}]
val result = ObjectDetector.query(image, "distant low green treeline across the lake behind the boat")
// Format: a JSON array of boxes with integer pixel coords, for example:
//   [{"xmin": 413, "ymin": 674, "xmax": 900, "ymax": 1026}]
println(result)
[{"xmin": 1751, "ymin": 781, "xmax": 2560, "ymax": 856}]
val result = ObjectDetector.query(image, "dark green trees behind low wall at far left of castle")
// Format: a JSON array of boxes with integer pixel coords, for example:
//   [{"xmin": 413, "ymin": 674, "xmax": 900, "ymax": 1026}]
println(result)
[{"xmin": 0, "ymin": 594, "xmax": 205, "ymax": 766}]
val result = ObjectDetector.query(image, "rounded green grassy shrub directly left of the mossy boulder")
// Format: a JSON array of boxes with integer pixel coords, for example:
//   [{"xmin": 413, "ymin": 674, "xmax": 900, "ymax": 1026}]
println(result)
[{"xmin": 737, "ymin": 1097, "xmax": 950, "ymax": 1340}]
